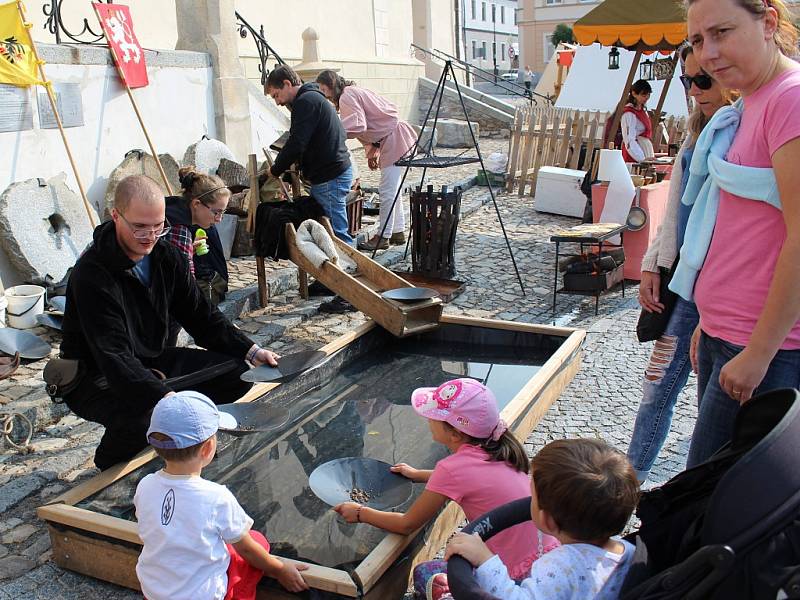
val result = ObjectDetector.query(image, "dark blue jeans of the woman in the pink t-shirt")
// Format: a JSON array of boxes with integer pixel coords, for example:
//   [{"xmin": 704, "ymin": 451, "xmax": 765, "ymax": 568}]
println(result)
[{"xmin": 686, "ymin": 333, "xmax": 800, "ymax": 468}]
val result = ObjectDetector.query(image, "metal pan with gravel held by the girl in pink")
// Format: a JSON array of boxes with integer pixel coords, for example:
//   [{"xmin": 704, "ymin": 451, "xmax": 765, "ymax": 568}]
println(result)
[{"xmin": 308, "ymin": 458, "xmax": 412, "ymax": 510}]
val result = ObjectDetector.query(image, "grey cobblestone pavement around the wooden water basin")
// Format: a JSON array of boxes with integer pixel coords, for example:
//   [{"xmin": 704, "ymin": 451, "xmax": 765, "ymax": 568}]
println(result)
[{"xmin": 0, "ymin": 142, "xmax": 695, "ymax": 600}]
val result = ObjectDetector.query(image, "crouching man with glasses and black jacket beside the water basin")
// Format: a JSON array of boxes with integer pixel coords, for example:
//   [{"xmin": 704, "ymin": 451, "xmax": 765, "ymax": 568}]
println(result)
[{"xmin": 61, "ymin": 175, "xmax": 276, "ymax": 469}]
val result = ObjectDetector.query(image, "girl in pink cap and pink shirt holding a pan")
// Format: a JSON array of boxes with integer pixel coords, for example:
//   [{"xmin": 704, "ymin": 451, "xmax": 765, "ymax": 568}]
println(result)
[{"xmin": 334, "ymin": 378, "xmax": 559, "ymax": 592}]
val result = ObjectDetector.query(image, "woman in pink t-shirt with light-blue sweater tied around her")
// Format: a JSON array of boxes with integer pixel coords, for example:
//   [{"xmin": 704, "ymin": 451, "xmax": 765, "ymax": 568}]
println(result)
[{"xmin": 684, "ymin": 0, "xmax": 800, "ymax": 466}]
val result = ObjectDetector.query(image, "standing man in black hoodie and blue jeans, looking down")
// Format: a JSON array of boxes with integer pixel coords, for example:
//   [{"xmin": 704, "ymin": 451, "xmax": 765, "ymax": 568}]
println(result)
[{"xmin": 267, "ymin": 65, "xmax": 353, "ymax": 244}]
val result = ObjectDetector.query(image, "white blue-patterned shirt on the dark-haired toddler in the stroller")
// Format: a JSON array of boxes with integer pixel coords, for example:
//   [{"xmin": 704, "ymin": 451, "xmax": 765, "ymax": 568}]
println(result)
[{"xmin": 476, "ymin": 538, "xmax": 634, "ymax": 600}]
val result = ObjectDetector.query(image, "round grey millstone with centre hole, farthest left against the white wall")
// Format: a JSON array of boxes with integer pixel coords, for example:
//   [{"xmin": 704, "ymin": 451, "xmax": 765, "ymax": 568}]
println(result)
[{"xmin": 0, "ymin": 173, "xmax": 98, "ymax": 281}]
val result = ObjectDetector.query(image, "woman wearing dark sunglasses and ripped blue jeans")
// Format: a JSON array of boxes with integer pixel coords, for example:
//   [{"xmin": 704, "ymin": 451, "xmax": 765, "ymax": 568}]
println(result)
[{"xmin": 628, "ymin": 46, "xmax": 733, "ymax": 483}]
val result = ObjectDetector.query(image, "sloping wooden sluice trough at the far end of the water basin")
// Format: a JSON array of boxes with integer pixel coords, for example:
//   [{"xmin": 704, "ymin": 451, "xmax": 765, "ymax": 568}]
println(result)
[{"xmin": 286, "ymin": 219, "xmax": 443, "ymax": 337}]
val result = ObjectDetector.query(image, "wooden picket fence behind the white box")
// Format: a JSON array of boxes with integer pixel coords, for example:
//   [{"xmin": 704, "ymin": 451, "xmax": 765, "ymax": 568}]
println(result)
[{"xmin": 506, "ymin": 107, "xmax": 686, "ymax": 196}]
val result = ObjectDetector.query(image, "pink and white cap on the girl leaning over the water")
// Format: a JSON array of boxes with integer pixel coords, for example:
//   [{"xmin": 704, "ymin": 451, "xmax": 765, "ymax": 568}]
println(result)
[{"xmin": 411, "ymin": 378, "xmax": 508, "ymax": 441}]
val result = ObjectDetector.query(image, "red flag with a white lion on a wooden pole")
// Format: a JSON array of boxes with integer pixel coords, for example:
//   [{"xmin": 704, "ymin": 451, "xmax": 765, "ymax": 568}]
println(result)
[{"xmin": 92, "ymin": 2, "xmax": 148, "ymax": 88}]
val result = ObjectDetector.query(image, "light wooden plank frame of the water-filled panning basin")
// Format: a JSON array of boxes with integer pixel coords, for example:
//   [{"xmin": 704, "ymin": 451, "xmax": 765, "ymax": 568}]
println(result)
[{"xmin": 37, "ymin": 315, "xmax": 586, "ymax": 600}]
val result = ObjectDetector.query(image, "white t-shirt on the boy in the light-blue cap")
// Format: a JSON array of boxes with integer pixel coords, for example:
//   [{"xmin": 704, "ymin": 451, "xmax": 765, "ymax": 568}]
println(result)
[{"xmin": 133, "ymin": 471, "xmax": 253, "ymax": 600}]
